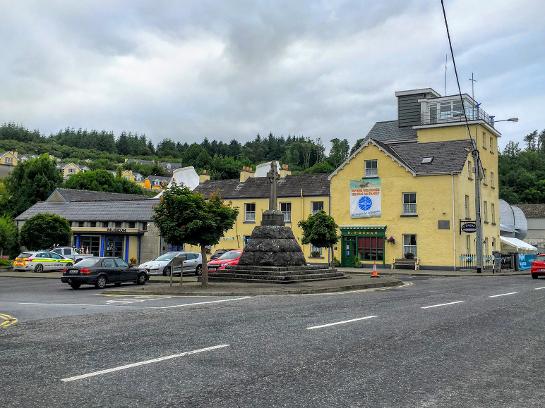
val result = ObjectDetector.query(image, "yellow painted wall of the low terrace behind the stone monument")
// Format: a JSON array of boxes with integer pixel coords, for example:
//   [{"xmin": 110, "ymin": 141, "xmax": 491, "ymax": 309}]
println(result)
[{"xmin": 186, "ymin": 196, "xmax": 329, "ymax": 263}]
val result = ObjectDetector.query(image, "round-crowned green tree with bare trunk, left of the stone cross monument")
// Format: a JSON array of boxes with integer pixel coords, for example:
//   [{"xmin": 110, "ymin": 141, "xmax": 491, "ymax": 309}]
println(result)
[{"xmin": 153, "ymin": 185, "xmax": 238, "ymax": 286}]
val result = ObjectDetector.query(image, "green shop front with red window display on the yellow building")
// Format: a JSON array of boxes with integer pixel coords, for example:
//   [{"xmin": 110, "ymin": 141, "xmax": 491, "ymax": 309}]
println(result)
[{"xmin": 340, "ymin": 226, "xmax": 386, "ymax": 267}]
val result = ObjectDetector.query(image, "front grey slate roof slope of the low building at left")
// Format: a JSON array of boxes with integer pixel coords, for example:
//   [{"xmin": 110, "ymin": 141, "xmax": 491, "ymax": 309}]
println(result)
[{"xmin": 15, "ymin": 199, "xmax": 159, "ymax": 221}]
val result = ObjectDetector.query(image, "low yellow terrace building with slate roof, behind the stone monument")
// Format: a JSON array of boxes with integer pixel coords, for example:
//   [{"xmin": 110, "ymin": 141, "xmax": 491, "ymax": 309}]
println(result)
[{"xmin": 190, "ymin": 167, "xmax": 329, "ymax": 263}]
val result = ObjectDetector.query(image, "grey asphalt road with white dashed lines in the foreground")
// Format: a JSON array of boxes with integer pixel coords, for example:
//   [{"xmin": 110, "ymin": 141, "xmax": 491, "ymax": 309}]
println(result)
[{"xmin": 0, "ymin": 276, "xmax": 545, "ymax": 407}]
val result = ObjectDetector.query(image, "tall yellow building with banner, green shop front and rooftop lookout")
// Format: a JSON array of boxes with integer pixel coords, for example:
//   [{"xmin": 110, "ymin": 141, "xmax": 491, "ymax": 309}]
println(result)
[{"xmin": 330, "ymin": 88, "xmax": 500, "ymax": 268}]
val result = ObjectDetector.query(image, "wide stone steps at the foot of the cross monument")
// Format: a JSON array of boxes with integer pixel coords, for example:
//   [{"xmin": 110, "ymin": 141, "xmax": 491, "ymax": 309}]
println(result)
[{"xmin": 208, "ymin": 265, "xmax": 346, "ymax": 283}]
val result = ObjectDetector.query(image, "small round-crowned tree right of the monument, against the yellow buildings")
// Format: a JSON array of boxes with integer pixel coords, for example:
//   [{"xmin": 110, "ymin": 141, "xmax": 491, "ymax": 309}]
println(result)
[{"xmin": 298, "ymin": 211, "xmax": 339, "ymax": 265}]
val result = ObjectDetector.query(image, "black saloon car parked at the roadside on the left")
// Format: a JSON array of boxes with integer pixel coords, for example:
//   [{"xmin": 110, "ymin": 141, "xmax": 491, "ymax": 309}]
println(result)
[{"xmin": 61, "ymin": 257, "xmax": 149, "ymax": 289}]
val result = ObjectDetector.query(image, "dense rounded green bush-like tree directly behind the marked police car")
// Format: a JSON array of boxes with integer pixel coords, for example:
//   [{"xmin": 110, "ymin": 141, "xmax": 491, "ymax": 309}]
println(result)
[{"xmin": 21, "ymin": 214, "xmax": 70, "ymax": 250}]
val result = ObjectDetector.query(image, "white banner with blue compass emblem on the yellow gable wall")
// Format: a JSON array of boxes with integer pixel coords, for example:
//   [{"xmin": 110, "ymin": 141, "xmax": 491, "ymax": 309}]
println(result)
[{"xmin": 350, "ymin": 178, "xmax": 381, "ymax": 218}]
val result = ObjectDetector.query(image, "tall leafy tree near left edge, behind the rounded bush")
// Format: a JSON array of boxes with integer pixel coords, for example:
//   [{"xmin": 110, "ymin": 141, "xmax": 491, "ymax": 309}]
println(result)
[{"xmin": 4, "ymin": 155, "xmax": 62, "ymax": 216}]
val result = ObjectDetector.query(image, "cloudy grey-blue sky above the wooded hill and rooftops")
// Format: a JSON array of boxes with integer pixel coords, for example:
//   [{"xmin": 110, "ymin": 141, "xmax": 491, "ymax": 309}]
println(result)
[{"xmin": 0, "ymin": 0, "xmax": 545, "ymax": 151}]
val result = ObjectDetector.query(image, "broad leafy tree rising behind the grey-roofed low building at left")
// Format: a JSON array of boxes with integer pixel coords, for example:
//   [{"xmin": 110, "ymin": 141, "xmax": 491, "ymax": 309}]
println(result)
[{"xmin": 64, "ymin": 170, "xmax": 144, "ymax": 194}]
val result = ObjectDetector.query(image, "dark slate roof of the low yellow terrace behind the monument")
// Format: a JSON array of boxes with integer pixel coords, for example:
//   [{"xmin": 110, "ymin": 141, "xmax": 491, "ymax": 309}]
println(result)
[{"xmin": 195, "ymin": 174, "xmax": 329, "ymax": 199}]
